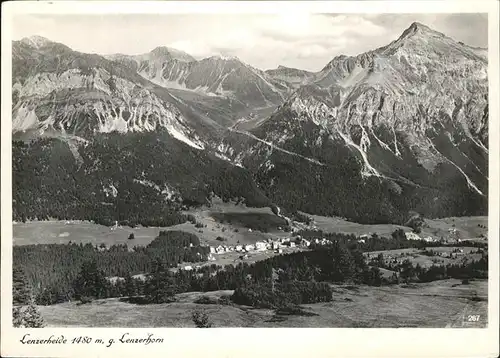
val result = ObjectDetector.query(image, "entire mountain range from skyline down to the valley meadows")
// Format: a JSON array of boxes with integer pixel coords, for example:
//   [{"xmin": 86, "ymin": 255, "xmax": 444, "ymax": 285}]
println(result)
[{"xmin": 12, "ymin": 23, "xmax": 488, "ymax": 223}]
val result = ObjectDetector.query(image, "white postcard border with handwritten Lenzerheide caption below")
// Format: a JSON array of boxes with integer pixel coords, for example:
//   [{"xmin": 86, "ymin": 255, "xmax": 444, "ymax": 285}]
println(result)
[{"xmin": 1, "ymin": 1, "xmax": 500, "ymax": 357}]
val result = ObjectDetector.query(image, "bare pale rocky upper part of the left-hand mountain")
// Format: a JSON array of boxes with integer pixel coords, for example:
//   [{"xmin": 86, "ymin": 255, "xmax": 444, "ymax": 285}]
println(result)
[{"xmin": 12, "ymin": 37, "xmax": 207, "ymax": 148}]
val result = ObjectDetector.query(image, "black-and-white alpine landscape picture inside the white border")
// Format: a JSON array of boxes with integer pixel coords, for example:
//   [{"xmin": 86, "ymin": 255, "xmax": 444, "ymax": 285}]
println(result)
[{"xmin": 2, "ymin": 2, "xmax": 498, "ymax": 356}]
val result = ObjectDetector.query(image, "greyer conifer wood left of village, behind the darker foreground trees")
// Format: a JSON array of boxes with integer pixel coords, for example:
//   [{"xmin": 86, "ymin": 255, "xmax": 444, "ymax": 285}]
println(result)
[{"xmin": 13, "ymin": 231, "xmax": 209, "ymax": 302}]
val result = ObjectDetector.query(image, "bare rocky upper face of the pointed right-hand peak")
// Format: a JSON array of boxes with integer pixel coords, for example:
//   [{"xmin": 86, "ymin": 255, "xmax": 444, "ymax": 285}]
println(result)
[{"xmin": 250, "ymin": 23, "xmax": 488, "ymax": 195}]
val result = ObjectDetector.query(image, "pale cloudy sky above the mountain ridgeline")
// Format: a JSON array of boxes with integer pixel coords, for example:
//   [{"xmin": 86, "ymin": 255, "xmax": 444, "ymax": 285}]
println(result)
[{"xmin": 13, "ymin": 13, "xmax": 488, "ymax": 71}]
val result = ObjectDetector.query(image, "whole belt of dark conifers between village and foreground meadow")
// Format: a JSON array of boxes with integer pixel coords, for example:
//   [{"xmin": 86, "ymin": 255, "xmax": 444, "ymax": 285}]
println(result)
[{"xmin": 14, "ymin": 235, "xmax": 382, "ymax": 304}]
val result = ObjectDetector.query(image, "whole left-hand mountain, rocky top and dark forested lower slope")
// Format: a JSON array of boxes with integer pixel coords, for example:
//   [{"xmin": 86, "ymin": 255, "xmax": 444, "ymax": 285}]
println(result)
[{"xmin": 12, "ymin": 37, "xmax": 276, "ymax": 226}]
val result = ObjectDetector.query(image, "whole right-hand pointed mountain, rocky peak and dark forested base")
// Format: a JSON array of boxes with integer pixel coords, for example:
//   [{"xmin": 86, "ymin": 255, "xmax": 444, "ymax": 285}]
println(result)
[{"xmin": 219, "ymin": 23, "xmax": 488, "ymax": 222}]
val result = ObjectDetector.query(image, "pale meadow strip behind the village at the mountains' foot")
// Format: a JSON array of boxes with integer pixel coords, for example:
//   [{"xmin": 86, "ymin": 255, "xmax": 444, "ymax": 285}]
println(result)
[{"xmin": 13, "ymin": 202, "xmax": 488, "ymax": 247}]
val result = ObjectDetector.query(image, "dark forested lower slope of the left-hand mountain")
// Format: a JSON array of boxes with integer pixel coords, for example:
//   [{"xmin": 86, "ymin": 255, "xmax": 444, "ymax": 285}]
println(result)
[{"xmin": 12, "ymin": 132, "xmax": 270, "ymax": 226}]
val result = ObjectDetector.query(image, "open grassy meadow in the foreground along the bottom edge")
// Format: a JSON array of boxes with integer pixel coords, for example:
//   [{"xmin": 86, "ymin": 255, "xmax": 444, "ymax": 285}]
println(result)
[{"xmin": 39, "ymin": 279, "xmax": 488, "ymax": 328}]
